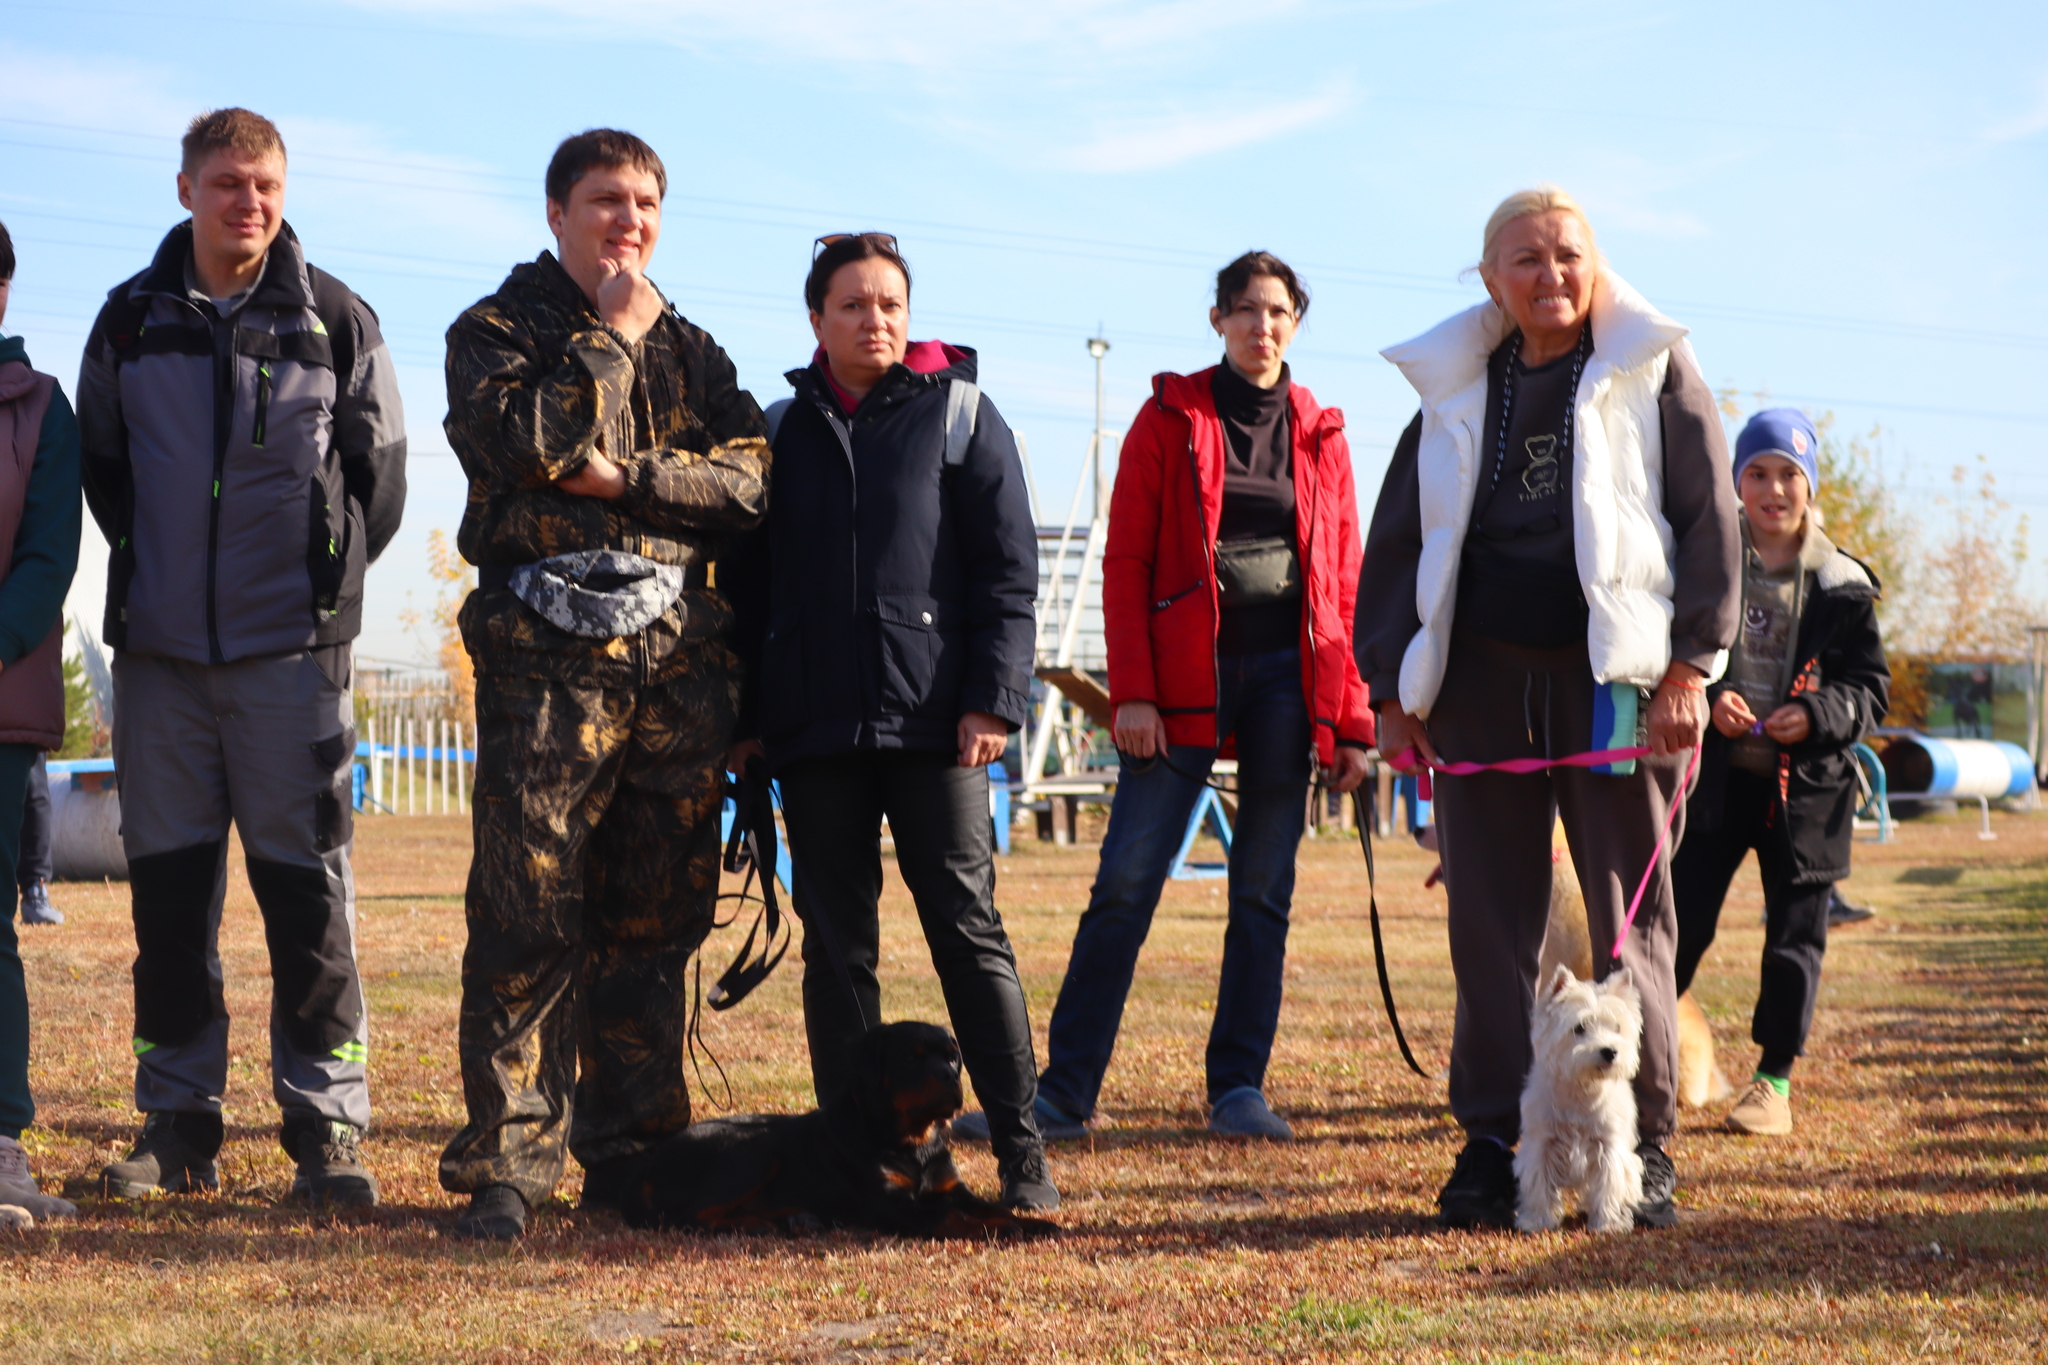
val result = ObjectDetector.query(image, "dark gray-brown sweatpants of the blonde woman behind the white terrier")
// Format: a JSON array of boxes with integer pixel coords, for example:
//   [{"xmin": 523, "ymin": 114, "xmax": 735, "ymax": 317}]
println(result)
[{"xmin": 1430, "ymin": 634, "xmax": 1690, "ymax": 1146}]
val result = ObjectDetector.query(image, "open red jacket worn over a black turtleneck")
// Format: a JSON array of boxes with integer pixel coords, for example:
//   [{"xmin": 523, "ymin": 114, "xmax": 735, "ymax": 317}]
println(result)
[{"xmin": 1102, "ymin": 368, "xmax": 1372, "ymax": 765}]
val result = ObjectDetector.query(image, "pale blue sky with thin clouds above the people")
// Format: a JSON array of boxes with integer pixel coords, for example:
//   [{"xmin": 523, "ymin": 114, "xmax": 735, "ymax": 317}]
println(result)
[{"xmin": 0, "ymin": 0, "xmax": 2048, "ymax": 659}]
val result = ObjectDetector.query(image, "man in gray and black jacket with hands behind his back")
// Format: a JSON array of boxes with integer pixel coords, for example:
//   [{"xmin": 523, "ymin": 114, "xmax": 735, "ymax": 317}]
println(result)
[{"xmin": 78, "ymin": 108, "xmax": 406, "ymax": 1205}]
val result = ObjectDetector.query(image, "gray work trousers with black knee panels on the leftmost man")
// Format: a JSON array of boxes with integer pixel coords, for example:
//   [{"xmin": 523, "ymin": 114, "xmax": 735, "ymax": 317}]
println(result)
[{"xmin": 113, "ymin": 645, "xmax": 371, "ymax": 1128}]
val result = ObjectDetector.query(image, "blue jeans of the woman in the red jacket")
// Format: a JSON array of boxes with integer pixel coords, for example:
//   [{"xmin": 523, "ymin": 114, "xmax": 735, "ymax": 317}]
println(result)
[{"xmin": 1038, "ymin": 649, "xmax": 1311, "ymax": 1117}]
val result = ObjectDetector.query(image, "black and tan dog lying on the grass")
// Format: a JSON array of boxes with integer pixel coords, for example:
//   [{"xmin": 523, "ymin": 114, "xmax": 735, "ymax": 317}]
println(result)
[{"xmin": 618, "ymin": 1023, "xmax": 1059, "ymax": 1238}]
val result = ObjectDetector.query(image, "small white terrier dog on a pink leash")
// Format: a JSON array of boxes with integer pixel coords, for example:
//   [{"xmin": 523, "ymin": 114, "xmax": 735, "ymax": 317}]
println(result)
[{"xmin": 1516, "ymin": 966, "xmax": 1642, "ymax": 1232}]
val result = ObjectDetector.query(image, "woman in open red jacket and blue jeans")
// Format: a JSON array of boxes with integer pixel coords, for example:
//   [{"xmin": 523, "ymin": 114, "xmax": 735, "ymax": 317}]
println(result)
[{"xmin": 962, "ymin": 252, "xmax": 1372, "ymax": 1138}]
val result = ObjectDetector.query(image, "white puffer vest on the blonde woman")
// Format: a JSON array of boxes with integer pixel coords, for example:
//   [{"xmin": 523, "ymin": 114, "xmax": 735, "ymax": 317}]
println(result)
[{"xmin": 1380, "ymin": 270, "xmax": 1724, "ymax": 718}]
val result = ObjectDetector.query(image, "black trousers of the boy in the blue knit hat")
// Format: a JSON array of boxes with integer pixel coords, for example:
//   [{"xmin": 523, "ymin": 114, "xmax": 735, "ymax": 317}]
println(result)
[{"xmin": 1671, "ymin": 767, "xmax": 1833, "ymax": 1076}]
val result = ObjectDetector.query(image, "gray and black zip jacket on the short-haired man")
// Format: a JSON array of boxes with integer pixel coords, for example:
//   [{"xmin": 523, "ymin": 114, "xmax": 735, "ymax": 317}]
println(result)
[{"xmin": 78, "ymin": 221, "xmax": 406, "ymax": 663}]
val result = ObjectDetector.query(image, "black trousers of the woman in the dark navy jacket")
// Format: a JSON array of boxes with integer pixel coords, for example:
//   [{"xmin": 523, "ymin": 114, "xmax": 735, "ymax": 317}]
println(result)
[{"xmin": 780, "ymin": 749, "xmax": 1040, "ymax": 1158}]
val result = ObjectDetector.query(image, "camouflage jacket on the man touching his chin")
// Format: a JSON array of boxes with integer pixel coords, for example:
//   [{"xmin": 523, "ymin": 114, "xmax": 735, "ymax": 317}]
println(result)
[{"xmin": 446, "ymin": 252, "xmax": 770, "ymax": 688}]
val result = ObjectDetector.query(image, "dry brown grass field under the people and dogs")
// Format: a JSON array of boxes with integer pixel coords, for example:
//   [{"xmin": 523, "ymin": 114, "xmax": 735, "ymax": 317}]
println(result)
[{"xmin": 0, "ymin": 802, "xmax": 2048, "ymax": 1365}]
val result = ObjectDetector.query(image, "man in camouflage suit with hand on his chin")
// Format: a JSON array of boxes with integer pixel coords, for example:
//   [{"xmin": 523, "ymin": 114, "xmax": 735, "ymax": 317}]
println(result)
[{"xmin": 440, "ymin": 129, "xmax": 768, "ymax": 1238}]
